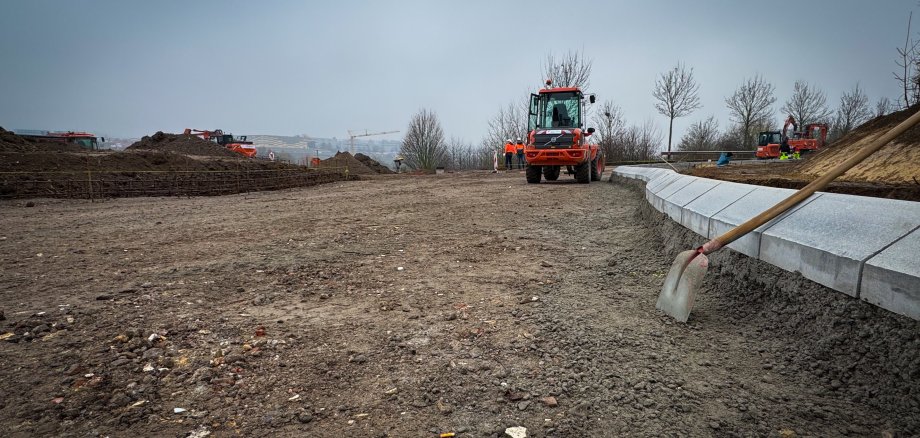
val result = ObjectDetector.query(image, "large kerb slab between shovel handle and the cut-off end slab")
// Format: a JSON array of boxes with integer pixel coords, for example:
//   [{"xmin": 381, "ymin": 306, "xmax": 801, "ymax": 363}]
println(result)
[{"xmin": 760, "ymin": 193, "xmax": 920, "ymax": 297}]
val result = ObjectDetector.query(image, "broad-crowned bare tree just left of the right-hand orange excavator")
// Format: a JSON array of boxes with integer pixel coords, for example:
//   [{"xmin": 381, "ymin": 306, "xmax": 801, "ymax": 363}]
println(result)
[{"xmin": 725, "ymin": 75, "xmax": 776, "ymax": 149}]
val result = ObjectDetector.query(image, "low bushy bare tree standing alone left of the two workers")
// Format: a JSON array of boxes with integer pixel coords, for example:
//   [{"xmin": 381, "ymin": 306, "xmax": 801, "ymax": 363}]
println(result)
[{"xmin": 399, "ymin": 108, "xmax": 447, "ymax": 170}]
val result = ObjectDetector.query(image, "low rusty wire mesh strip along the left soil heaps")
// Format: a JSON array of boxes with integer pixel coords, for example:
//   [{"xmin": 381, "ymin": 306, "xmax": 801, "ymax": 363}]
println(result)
[{"xmin": 0, "ymin": 167, "xmax": 353, "ymax": 199}]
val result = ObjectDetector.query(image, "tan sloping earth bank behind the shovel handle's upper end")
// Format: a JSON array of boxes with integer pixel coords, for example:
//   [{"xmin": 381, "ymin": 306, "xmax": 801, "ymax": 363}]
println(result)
[{"xmin": 793, "ymin": 105, "xmax": 920, "ymax": 184}]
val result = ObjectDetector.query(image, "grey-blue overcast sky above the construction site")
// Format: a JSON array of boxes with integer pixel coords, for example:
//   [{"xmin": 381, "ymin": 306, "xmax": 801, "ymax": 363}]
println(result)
[{"xmin": 0, "ymin": 0, "xmax": 920, "ymax": 144}]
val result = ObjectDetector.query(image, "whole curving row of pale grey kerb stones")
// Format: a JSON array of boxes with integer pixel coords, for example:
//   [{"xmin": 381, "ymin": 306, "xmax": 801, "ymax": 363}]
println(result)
[{"xmin": 611, "ymin": 164, "xmax": 920, "ymax": 320}]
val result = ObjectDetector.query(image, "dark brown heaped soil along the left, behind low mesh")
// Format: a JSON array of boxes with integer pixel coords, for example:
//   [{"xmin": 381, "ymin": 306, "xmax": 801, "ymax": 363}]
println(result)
[{"xmin": 0, "ymin": 128, "xmax": 354, "ymax": 199}]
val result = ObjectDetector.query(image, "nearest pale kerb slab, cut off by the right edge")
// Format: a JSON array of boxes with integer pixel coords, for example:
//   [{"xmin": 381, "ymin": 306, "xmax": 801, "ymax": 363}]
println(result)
[{"xmin": 859, "ymin": 229, "xmax": 920, "ymax": 320}]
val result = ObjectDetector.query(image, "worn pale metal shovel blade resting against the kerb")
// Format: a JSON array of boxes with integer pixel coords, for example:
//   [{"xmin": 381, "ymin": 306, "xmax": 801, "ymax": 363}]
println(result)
[{"xmin": 655, "ymin": 250, "xmax": 709, "ymax": 322}]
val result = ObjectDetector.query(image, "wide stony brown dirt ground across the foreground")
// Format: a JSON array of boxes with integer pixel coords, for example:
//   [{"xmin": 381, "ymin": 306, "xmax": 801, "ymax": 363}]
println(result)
[{"xmin": 0, "ymin": 172, "xmax": 920, "ymax": 438}]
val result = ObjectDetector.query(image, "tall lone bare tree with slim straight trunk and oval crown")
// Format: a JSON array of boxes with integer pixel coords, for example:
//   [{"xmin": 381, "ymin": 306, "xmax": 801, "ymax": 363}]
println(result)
[{"xmin": 652, "ymin": 63, "xmax": 701, "ymax": 152}]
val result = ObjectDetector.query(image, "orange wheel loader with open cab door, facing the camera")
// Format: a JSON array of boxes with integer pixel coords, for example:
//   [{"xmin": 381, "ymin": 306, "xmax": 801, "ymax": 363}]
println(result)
[{"xmin": 524, "ymin": 81, "xmax": 604, "ymax": 184}]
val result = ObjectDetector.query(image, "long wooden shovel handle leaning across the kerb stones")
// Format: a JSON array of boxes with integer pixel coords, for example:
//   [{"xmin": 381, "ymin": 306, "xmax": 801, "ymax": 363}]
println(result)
[{"xmin": 698, "ymin": 107, "xmax": 920, "ymax": 254}]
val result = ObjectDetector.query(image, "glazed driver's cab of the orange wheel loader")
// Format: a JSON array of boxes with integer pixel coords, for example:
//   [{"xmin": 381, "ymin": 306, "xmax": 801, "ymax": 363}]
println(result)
[{"xmin": 527, "ymin": 87, "xmax": 593, "ymax": 131}]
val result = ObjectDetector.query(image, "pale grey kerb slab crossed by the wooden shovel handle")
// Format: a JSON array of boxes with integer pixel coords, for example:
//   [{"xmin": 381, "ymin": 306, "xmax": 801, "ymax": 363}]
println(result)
[{"xmin": 708, "ymin": 187, "xmax": 807, "ymax": 258}]
